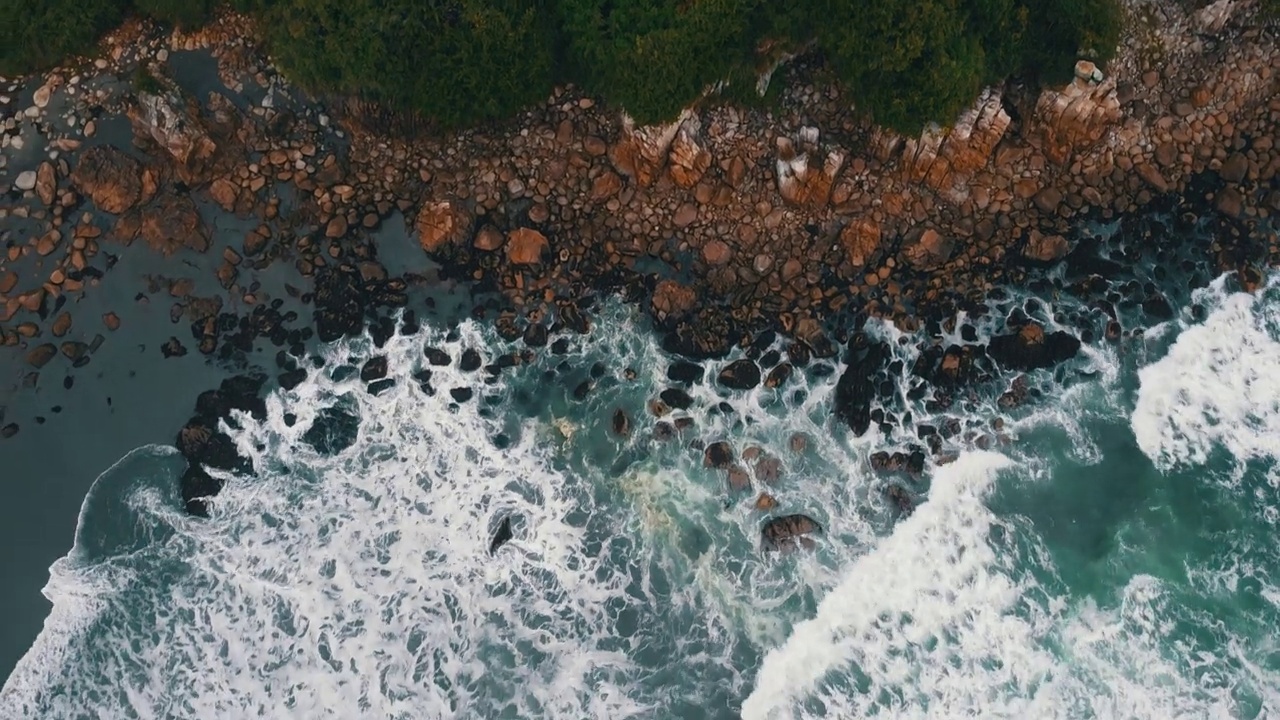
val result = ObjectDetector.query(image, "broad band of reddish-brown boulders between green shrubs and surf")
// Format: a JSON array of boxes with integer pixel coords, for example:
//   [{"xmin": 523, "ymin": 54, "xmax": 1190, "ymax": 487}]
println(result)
[{"xmin": 0, "ymin": 0, "xmax": 1280, "ymax": 511}]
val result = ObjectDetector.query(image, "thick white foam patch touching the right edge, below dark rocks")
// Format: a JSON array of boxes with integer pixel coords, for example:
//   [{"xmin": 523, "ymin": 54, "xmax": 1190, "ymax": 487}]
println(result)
[{"xmin": 1132, "ymin": 271, "xmax": 1280, "ymax": 469}]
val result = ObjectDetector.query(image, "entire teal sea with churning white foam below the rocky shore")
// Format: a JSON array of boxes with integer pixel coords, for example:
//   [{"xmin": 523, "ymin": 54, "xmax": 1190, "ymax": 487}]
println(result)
[{"xmin": 0, "ymin": 270, "xmax": 1280, "ymax": 719}]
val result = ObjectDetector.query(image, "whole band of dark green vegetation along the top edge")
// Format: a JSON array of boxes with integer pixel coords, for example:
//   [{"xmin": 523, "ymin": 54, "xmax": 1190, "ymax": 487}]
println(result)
[{"xmin": 0, "ymin": 0, "xmax": 1121, "ymax": 132}]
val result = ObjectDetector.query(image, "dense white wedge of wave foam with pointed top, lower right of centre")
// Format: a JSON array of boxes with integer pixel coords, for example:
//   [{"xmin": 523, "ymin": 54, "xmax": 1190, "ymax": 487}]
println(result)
[{"xmin": 742, "ymin": 452, "xmax": 1052, "ymax": 720}]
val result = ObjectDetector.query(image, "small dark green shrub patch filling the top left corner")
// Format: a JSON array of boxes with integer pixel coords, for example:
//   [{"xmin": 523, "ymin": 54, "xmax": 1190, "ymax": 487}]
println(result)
[{"xmin": 0, "ymin": 0, "xmax": 123, "ymax": 74}]
